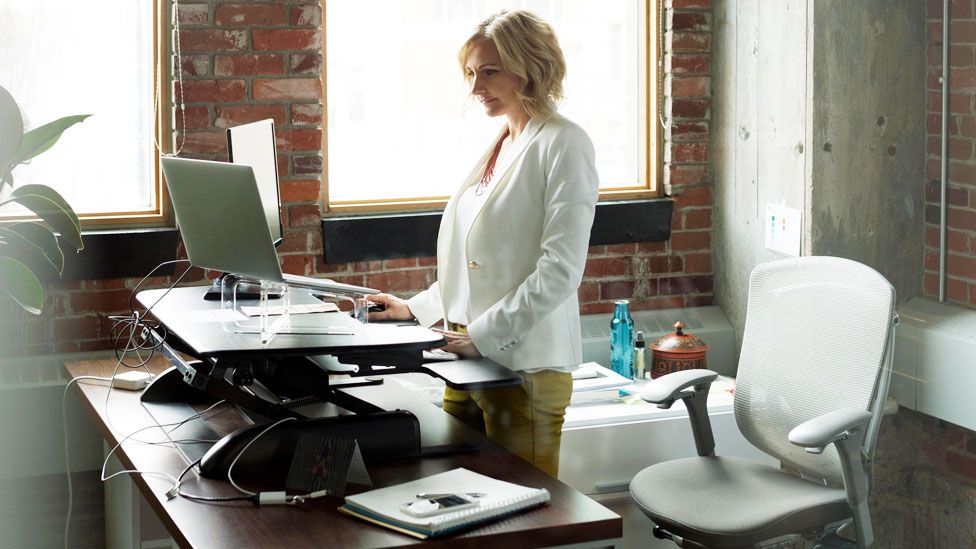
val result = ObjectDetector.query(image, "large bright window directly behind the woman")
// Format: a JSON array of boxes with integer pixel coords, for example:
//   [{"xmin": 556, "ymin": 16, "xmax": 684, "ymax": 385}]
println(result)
[{"xmin": 324, "ymin": 0, "xmax": 660, "ymax": 211}]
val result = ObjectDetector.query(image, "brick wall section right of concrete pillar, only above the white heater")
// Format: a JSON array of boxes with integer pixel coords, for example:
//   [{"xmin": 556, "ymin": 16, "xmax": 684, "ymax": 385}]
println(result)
[{"xmin": 924, "ymin": 0, "xmax": 976, "ymax": 306}]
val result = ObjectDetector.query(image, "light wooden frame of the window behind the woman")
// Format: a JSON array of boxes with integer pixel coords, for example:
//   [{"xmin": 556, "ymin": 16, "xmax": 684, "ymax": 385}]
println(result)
[{"xmin": 320, "ymin": 0, "xmax": 665, "ymax": 215}]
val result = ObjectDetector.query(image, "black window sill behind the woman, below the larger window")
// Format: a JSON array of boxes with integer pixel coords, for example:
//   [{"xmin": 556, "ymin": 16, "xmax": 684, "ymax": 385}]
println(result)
[{"xmin": 322, "ymin": 198, "xmax": 674, "ymax": 264}]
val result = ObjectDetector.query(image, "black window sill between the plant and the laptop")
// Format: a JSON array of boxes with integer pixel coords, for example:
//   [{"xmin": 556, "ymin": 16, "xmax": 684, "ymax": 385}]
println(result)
[{"xmin": 61, "ymin": 227, "xmax": 180, "ymax": 280}]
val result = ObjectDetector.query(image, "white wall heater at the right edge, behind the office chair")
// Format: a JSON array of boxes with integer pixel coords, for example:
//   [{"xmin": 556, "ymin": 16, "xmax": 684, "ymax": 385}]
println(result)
[{"xmin": 891, "ymin": 298, "xmax": 976, "ymax": 430}]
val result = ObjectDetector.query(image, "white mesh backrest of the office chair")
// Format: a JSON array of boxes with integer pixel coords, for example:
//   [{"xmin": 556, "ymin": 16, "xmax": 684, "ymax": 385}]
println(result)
[{"xmin": 735, "ymin": 257, "xmax": 895, "ymax": 484}]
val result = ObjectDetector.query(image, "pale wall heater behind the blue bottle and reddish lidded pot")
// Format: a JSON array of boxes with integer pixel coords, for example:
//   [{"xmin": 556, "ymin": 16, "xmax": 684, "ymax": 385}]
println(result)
[{"xmin": 580, "ymin": 306, "xmax": 735, "ymax": 376}]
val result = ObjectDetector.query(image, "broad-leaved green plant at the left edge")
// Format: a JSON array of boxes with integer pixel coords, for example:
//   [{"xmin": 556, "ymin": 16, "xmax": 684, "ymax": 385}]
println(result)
[{"xmin": 0, "ymin": 86, "xmax": 90, "ymax": 314}]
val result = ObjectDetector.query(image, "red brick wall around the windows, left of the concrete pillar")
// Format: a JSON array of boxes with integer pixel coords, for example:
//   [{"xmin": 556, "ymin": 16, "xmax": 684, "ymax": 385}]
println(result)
[{"xmin": 0, "ymin": 0, "xmax": 713, "ymax": 355}]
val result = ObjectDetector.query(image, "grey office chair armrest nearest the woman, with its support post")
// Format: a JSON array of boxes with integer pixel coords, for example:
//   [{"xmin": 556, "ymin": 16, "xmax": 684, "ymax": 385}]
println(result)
[{"xmin": 641, "ymin": 370, "xmax": 718, "ymax": 456}]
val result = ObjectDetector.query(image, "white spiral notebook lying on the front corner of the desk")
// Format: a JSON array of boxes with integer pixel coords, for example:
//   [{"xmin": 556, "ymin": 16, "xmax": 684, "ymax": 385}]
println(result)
[{"xmin": 339, "ymin": 468, "xmax": 549, "ymax": 539}]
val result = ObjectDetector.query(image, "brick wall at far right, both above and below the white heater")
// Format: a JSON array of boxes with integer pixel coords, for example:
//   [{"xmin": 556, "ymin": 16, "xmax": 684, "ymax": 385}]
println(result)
[{"xmin": 871, "ymin": 0, "xmax": 976, "ymax": 549}]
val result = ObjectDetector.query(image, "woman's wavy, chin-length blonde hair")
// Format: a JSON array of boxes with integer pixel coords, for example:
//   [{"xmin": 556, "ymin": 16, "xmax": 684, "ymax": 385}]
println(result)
[{"xmin": 458, "ymin": 10, "xmax": 566, "ymax": 117}]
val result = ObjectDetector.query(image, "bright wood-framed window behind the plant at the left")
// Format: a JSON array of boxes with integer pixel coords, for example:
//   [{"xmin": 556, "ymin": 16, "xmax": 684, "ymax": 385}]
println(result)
[{"xmin": 0, "ymin": 0, "xmax": 165, "ymax": 225}]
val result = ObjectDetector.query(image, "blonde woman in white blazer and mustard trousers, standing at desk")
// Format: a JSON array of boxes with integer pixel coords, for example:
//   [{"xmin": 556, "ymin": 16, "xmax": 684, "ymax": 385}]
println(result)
[{"xmin": 370, "ymin": 10, "xmax": 599, "ymax": 477}]
